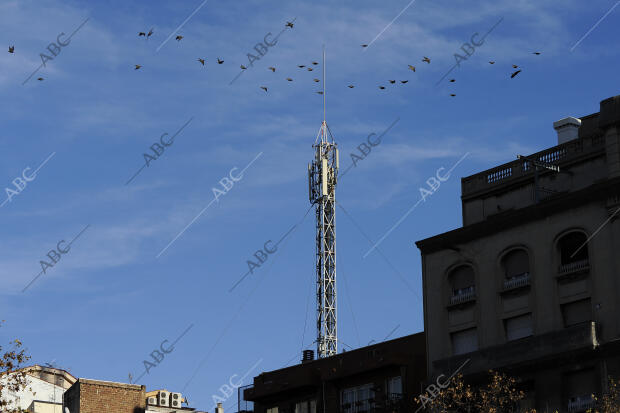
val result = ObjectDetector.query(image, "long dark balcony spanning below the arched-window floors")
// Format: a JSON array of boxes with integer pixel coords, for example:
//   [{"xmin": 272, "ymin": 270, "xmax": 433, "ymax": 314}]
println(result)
[{"xmin": 433, "ymin": 322, "xmax": 599, "ymax": 375}]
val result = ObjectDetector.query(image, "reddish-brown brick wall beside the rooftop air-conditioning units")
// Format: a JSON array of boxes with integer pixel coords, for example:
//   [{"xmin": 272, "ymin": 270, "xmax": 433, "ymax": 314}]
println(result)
[{"xmin": 64, "ymin": 379, "xmax": 146, "ymax": 413}]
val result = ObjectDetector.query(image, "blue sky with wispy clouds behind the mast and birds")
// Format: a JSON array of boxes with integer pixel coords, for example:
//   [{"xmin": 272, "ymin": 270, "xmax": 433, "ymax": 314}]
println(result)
[{"xmin": 0, "ymin": 0, "xmax": 620, "ymax": 411}]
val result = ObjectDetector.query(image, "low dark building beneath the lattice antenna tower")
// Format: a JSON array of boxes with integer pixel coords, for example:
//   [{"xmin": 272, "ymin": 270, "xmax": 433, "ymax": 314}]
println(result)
[{"xmin": 240, "ymin": 333, "xmax": 426, "ymax": 413}]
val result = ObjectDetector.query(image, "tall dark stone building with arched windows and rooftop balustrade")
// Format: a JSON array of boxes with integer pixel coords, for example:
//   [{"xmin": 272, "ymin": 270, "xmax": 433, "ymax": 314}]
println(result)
[{"xmin": 416, "ymin": 96, "xmax": 620, "ymax": 412}]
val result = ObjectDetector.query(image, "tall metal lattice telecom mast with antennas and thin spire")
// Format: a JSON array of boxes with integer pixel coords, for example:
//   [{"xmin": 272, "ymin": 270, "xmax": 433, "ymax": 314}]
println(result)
[{"xmin": 308, "ymin": 48, "xmax": 339, "ymax": 358}]
